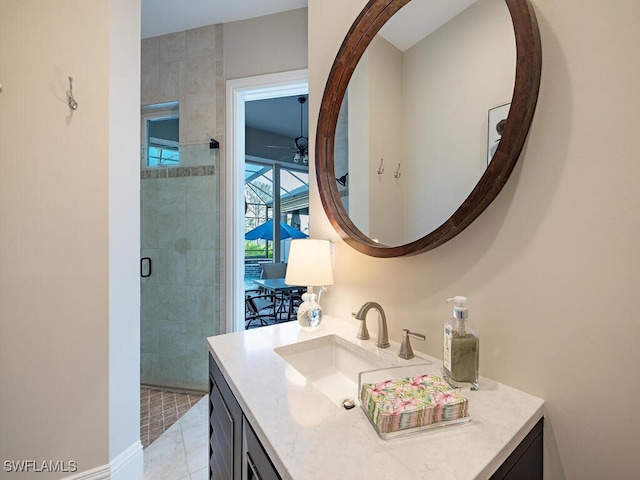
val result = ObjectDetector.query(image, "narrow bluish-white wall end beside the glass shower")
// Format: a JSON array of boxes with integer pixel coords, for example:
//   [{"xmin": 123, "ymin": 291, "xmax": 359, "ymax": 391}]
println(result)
[{"xmin": 109, "ymin": 0, "xmax": 143, "ymax": 474}]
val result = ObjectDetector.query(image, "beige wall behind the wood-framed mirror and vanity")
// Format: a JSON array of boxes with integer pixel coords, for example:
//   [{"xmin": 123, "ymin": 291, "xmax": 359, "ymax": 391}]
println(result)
[{"xmin": 309, "ymin": 0, "xmax": 640, "ymax": 480}]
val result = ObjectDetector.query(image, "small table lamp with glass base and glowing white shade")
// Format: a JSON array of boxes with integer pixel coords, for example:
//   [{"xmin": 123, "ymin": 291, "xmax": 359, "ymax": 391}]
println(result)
[{"xmin": 284, "ymin": 238, "xmax": 333, "ymax": 329}]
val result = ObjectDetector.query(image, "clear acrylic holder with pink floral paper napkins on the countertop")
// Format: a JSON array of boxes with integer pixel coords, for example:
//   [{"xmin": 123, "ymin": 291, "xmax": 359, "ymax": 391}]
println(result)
[{"xmin": 358, "ymin": 364, "xmax": 471, "ymax": 440}]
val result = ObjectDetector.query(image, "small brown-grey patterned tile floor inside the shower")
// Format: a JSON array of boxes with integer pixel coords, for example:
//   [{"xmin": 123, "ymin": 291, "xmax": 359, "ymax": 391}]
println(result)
[{"xmin": 140, "ymin": 385, "xmax": 204, "ymax": 448}]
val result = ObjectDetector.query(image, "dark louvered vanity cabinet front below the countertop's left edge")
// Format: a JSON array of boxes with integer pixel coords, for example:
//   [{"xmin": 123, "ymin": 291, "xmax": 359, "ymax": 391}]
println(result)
[{"xmin": 209, "ymin": 355, "xmax": 280, "ymax": 480}]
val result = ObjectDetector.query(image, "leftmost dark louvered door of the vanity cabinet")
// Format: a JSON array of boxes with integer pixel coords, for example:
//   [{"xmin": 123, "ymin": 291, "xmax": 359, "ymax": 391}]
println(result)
[{"xmin": 209, "ymin": 356, "xmax": 242, "ymax": 480}]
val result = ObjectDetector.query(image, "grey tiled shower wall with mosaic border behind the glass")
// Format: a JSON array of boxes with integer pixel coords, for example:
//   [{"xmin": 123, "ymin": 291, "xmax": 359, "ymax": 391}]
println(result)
[{"xmin": 140, "ymin": 25, "xmax": 224, "ymax": 390}]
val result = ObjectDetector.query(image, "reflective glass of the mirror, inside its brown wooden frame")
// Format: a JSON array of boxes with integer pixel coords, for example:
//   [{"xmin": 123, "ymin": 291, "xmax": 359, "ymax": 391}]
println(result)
[{"xmin": 334, "ymin": 0, "xmax": 516, "ymax": 246}]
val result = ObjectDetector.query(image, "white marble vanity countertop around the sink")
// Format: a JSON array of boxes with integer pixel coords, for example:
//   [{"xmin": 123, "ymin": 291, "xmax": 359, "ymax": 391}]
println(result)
[{"xmin": 207, "ymin": 316, "xmax": 544, "ymax": 480}]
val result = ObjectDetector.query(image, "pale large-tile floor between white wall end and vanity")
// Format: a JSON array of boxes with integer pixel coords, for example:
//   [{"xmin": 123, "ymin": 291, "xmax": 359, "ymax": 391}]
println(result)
[{"xmin": 140, "ymin": 395, "xmax": 209, "ymax": 480}]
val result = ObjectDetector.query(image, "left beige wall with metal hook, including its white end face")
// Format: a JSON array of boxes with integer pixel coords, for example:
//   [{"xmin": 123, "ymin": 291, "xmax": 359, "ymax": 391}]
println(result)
[{"xmin": 0, "ymin": 0, "xmax": 140, "ymax": 478}]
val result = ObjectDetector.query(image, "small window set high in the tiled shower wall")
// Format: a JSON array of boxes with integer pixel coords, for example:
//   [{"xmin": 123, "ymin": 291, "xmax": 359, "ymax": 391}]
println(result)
[{"xmin": 142, "ymin": 102, "xmax": 180, "ymax": 167}]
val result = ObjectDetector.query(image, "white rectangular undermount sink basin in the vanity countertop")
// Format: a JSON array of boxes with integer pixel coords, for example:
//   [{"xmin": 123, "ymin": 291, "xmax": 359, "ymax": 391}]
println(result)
[{"xmin": 274, "ymin": 335, "xmax": 390, "ymax": 406}]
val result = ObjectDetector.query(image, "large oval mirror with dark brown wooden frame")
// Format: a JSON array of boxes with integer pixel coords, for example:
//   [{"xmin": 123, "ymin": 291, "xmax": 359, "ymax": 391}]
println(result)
[{"xmin": 316, "ymin": 0, "xmax": 541, "ymax": 257}]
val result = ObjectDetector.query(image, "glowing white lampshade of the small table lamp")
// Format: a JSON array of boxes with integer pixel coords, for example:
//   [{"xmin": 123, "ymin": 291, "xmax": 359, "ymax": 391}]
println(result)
[{"xmin": 284, "ymin": 238, "xmax": 333, "ymax": 287}]
